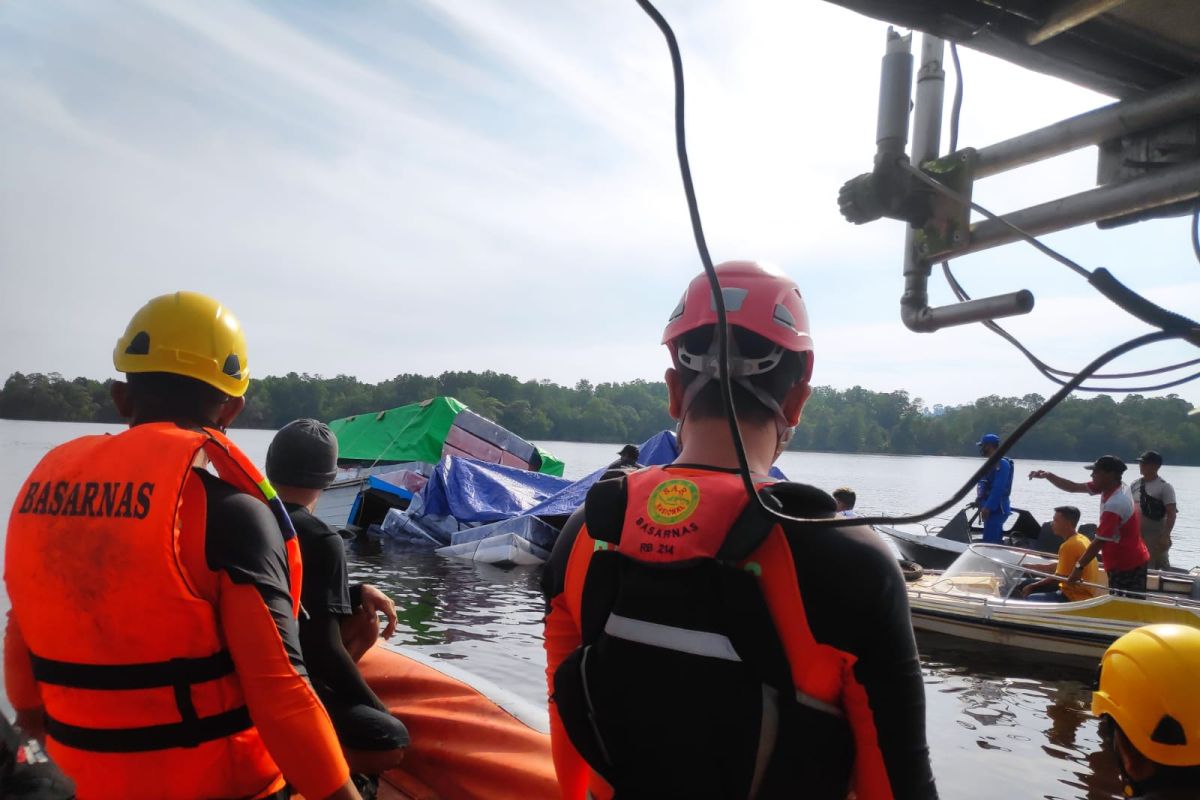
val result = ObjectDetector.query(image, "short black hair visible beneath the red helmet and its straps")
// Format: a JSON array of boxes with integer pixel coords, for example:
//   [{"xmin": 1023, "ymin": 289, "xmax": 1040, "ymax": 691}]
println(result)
[{"xmin": 672, "ymin": 325, "xmax": 809, "ymax": 422}]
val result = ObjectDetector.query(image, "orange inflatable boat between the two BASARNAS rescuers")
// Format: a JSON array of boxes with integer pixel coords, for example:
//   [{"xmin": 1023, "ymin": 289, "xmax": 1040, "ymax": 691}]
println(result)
[{"xmin": 359, "ymin": 644, "xmax": 560, "ymax": 800}]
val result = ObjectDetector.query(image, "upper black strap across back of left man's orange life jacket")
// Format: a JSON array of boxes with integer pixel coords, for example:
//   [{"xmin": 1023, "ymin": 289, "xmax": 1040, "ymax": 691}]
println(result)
[{"xmin": 29, "ymin": 650, "xmax": 233, "ymax": 690}]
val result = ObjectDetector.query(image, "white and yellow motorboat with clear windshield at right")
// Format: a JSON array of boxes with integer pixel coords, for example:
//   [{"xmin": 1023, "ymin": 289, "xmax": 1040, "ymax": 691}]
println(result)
[{"xmin": 908, "ymin": 545, "xmax": 1200, "ymax": 663}]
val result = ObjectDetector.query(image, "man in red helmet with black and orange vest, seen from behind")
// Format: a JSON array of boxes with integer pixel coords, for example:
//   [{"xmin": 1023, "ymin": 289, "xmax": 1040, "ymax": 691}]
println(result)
[{"xmin": 544, "ymin": 261, "xmax": 937, "ymax": 800}]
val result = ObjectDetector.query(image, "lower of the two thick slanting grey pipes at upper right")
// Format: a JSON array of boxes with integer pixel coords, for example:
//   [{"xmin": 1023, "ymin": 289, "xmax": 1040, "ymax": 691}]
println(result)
[{"xmin": 928, "ymin": 162, "xmax": 1200, "ymax": 261}]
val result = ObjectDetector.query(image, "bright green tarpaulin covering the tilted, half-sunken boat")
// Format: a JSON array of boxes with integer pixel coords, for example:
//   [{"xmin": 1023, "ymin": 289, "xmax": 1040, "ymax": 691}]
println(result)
[{"xmin": 329, "ymin": 397, "xmax": 563, "ymax": 476}]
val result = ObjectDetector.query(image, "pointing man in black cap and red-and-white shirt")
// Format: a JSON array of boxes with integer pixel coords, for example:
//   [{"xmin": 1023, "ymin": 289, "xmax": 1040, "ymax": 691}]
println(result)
[{"xmin": 1030, "ymin": 456, "xmax": 1150, "ymax": 595}]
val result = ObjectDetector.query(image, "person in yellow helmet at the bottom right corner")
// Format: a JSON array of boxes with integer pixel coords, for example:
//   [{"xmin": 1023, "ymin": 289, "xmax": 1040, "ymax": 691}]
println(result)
[{"xmin": 1092, "ymin": 625, "xmax": 1200, "ymax": 800}]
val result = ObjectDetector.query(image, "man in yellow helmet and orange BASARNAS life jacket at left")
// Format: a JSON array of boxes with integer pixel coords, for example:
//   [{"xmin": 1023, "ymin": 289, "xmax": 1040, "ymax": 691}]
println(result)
[{"xmin": 5, "ymin": 291, "xmax": 359, "ymax": 800}]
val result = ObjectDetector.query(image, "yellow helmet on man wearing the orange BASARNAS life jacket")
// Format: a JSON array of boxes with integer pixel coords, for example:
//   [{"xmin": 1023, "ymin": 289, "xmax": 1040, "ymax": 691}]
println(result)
[{"xmin": 113, "ymin": 291, "xmax": 250, "ymax": 397}]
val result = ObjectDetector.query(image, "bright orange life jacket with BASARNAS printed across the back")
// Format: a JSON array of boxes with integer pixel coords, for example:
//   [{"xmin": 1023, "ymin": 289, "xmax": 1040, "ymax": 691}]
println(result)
[{"xmin": 5, "ymin": 423, "xmax": 301, "ymax": 798}]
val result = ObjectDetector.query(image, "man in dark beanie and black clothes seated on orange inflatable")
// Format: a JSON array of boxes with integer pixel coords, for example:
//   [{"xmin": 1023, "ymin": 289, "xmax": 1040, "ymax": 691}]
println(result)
[{"xmin": 266, "ymin": 420, "xmax": 409, "ymax": 798}]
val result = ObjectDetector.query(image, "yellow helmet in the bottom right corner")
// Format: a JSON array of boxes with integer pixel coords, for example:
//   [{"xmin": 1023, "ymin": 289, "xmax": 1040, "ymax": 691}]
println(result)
[{"xmin": 1092, "ymin": 625, "xmax": 1200, "ymax": 766}]
